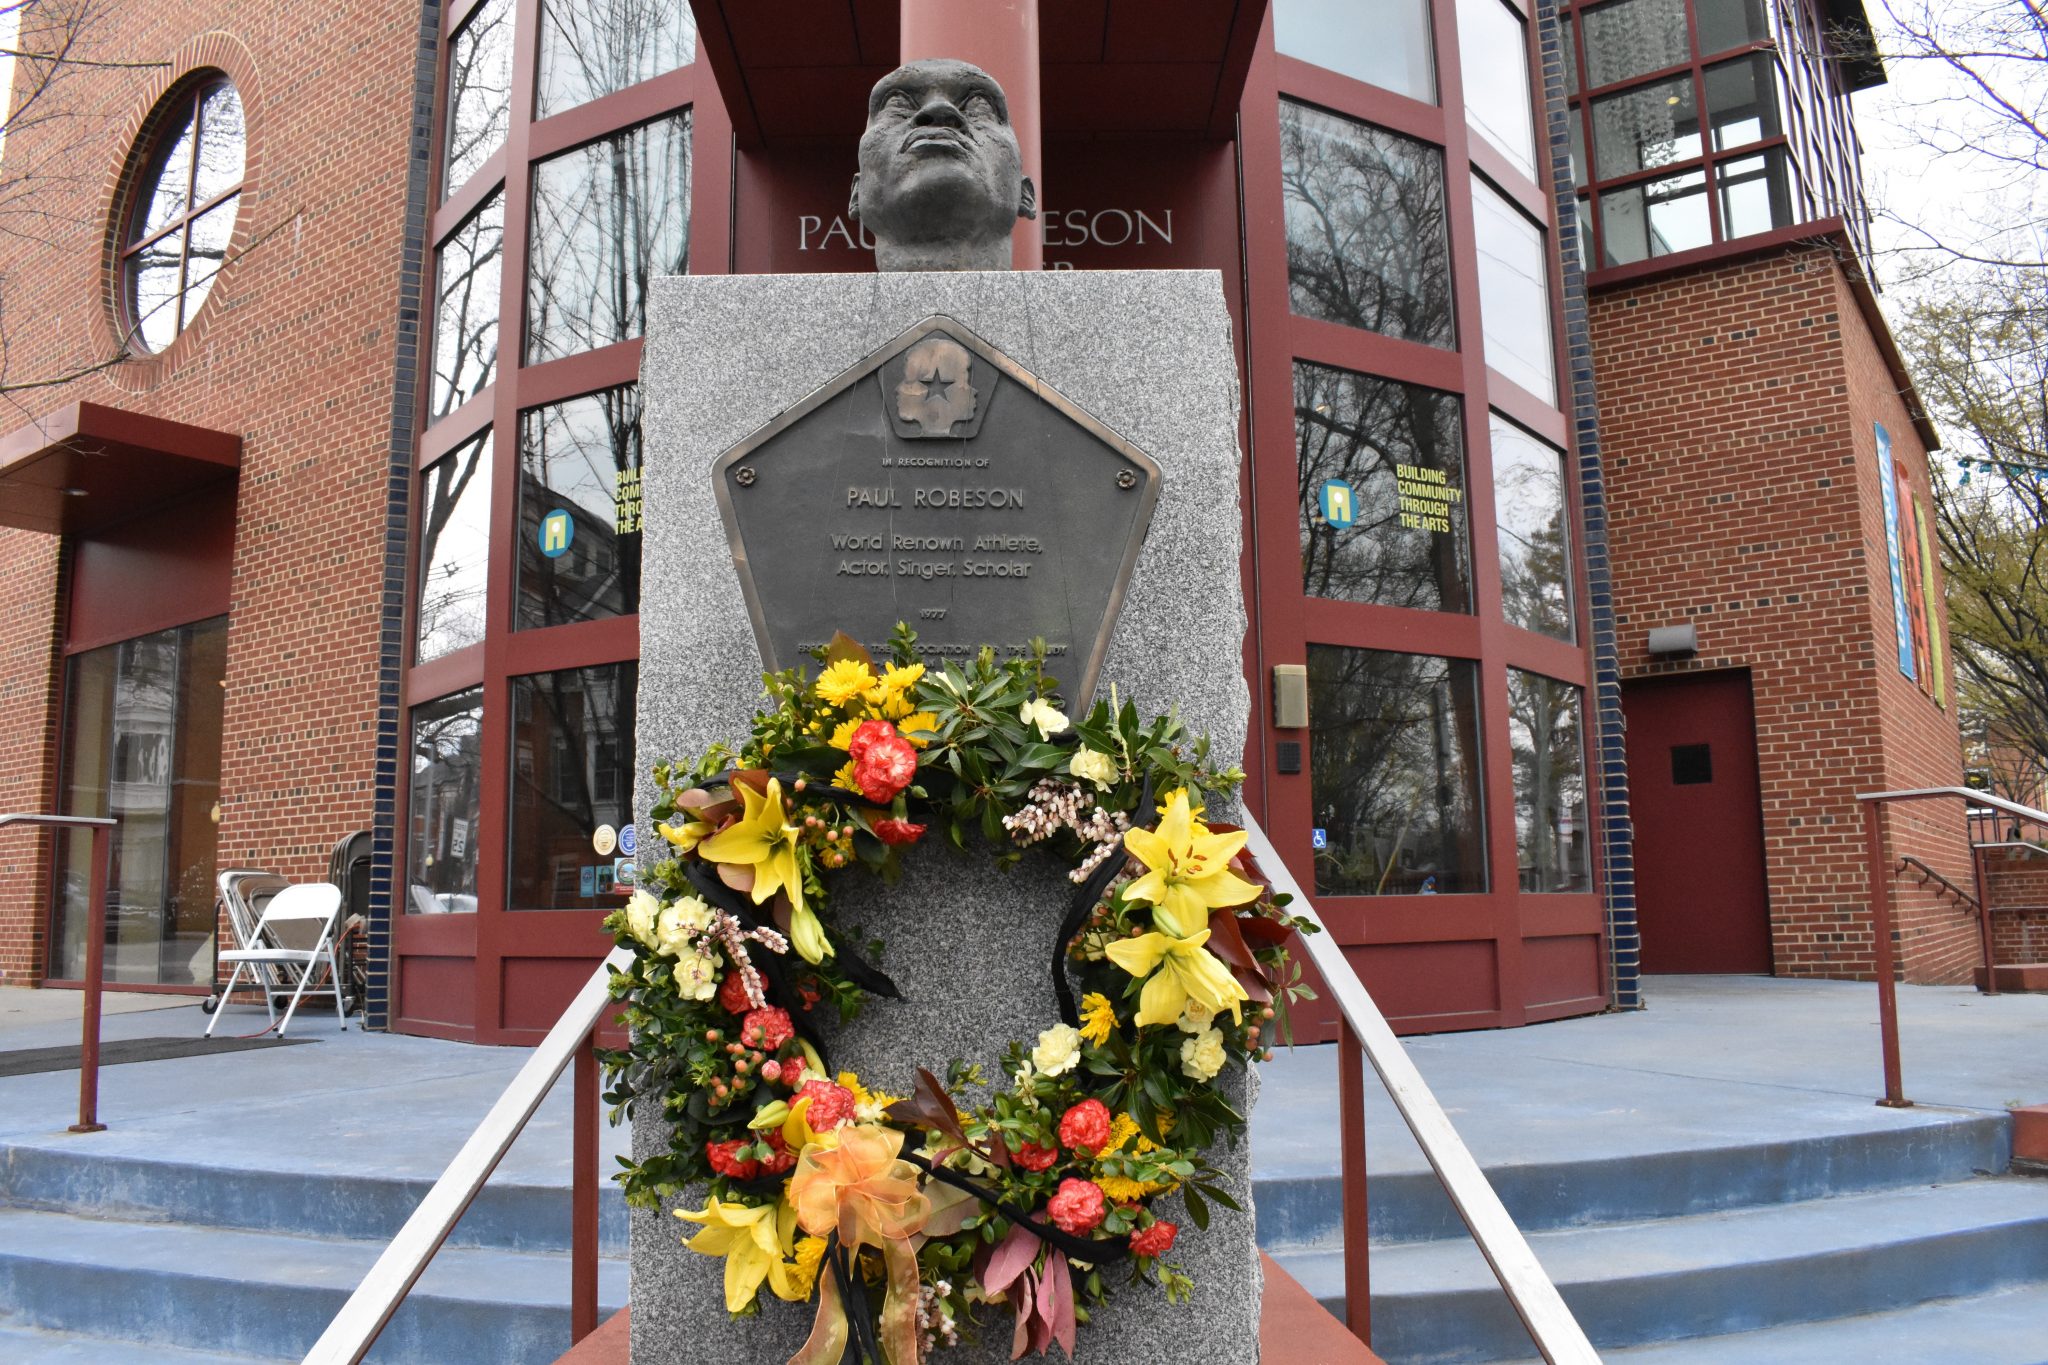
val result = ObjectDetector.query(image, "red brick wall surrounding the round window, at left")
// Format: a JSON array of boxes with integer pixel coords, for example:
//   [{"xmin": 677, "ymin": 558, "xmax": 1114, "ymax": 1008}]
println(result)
[{"xmin": 0, "ymin": 0, "xmax": 420, "ymax": 978}]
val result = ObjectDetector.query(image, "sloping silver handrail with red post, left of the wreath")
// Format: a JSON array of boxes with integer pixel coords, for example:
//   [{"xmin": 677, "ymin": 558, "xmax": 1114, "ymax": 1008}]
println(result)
[{"xmin": 305, "ymin": 948, "xmax": 633, "ymax": 1365}]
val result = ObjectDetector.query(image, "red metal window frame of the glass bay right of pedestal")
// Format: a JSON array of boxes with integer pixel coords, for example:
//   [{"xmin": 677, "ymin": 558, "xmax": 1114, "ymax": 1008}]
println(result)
[{"xmin": 1239, "ymin": 0, "xmax": 1606, "ymax": 1031}]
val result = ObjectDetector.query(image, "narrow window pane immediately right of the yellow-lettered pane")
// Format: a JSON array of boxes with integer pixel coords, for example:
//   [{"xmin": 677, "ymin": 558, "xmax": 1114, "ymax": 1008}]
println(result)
[{"xmin": 1489, "ymin": 413, "xmax": 1573, "ymax": 641}]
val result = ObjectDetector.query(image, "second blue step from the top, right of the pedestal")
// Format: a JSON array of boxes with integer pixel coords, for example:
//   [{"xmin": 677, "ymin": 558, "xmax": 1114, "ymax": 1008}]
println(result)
[{"xmin": 1274, "ymin": 1177, "xmax": 2048, "ymax": 1365}]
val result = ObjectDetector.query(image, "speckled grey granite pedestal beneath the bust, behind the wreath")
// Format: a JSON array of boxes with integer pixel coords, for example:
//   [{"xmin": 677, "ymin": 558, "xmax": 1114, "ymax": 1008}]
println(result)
[{"xmin": 631, "ymin": 272, "xmax": 1260, "ymax": 1365}]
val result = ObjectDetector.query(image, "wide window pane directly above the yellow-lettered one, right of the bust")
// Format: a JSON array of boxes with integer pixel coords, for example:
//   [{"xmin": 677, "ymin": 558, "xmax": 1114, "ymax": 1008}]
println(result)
[{"xmin": 1280, "ymin": 102, "xmax": 1458, "ymax": 346}]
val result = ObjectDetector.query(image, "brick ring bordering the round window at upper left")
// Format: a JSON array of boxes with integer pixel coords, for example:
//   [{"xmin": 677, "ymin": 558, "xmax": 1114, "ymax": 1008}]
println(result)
[{"xmin": 94, "ymin": 29, "xmax": 264, "ymax": 393}]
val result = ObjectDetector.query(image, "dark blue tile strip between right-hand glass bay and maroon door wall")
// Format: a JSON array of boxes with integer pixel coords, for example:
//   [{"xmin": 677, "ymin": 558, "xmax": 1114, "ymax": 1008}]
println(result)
[{"xmin": 1536, "ymin": 0, "xmax": 1642, "ymax": 1009}]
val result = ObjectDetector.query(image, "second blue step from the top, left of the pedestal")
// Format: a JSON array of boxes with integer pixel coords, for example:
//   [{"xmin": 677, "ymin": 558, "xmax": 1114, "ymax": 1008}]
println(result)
[{"xmin": 0, "ymin": 1209, "xmax": 627, "ymax": 1365}]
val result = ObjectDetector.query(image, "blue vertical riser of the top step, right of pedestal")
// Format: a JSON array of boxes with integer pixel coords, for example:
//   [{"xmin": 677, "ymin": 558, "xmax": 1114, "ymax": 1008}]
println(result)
[{"xmin": 1255, "ymin": 1111, "xmax": 2013, "ymax": 1254}]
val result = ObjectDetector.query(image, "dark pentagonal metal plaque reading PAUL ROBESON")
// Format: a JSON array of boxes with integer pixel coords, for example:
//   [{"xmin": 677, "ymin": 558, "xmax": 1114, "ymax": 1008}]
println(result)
[{"xmin": 713, "ymin": 317, "xmax": 1161, "ymax": 706}]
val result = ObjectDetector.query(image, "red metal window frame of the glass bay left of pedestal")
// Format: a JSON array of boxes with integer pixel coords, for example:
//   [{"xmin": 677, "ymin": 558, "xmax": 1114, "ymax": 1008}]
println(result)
[{"xmin": 391, "ymin": 0, "xmax": 731, "ymax": 1044}]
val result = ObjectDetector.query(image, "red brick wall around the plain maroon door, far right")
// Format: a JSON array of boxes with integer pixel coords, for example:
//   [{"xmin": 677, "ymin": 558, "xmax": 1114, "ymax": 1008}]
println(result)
[{"xmin": 1591, "ymin": 248, "xmax": 1968, "ymax": 980}]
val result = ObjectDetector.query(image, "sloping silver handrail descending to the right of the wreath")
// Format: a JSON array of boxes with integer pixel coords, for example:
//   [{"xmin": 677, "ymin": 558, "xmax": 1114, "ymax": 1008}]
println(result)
[{"xmin": 1243, "ymin": 814, "xmax": 1599, "ymax": 1365}]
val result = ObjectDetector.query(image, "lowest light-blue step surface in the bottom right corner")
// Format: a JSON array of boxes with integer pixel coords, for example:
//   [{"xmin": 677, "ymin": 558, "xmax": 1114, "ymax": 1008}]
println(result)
[{"xmin": 1518, "ymin": 1285, "xmax": 2048, "ymax": 1365}]
